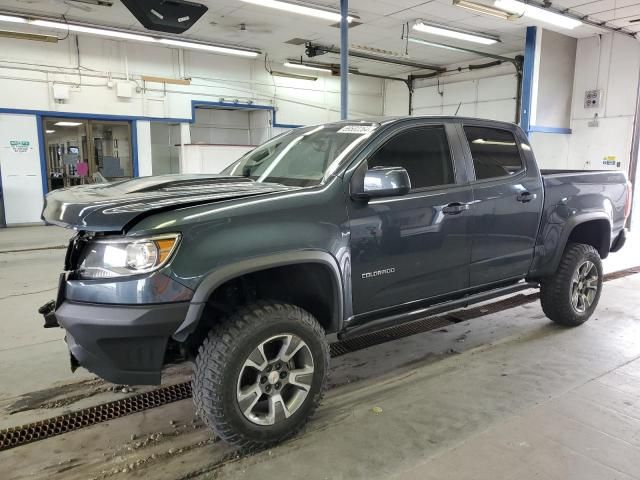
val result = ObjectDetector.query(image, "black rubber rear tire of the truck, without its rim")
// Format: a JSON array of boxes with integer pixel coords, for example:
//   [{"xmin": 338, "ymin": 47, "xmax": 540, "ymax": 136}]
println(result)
[{"xmin": 540, "ymin": 243, "xmax": 603, "ymax": 327}]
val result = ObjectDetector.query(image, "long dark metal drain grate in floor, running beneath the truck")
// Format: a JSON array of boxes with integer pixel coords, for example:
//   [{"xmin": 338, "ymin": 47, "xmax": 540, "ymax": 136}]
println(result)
[{"xmin": 0, "ymin": 266, "xmax": 640, "ymax": 451}]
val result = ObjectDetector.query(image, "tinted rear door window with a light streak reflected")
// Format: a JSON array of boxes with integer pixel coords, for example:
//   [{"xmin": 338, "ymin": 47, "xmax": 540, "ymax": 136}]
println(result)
[{"xmin": 464, "ymin": 126, "xmax": 524, "ymax": 180}]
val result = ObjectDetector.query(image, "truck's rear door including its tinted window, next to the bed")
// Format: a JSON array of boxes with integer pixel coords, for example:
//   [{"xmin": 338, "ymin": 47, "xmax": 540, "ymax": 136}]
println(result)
[{"xmin": 461, "ymin": 123, "xmax": 543, "ymax": 288}]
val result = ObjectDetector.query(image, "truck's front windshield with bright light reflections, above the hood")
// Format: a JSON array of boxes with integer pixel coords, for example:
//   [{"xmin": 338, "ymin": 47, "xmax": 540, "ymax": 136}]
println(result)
[{"xmin": 221, "ymin": 122, "xmax": 378, "ymax": 187}]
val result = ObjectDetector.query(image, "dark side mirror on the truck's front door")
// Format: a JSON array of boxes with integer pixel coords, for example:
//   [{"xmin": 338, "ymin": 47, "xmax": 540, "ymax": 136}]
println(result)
[{"xmin": 351, "ymin": 167, "xmax": 411, "ymax": 200}]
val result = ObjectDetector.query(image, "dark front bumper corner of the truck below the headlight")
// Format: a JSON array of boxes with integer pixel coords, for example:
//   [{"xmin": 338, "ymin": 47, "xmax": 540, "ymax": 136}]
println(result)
[{"xmin": 55, "ymin": 301, "xmax": 189, "ymax": 385}]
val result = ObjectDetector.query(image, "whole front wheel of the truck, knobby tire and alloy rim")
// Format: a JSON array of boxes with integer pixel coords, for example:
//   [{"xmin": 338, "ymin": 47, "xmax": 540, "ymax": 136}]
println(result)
[{"xmin": 192, "ymin": 302, "xmax": 329, "ymax": 450}]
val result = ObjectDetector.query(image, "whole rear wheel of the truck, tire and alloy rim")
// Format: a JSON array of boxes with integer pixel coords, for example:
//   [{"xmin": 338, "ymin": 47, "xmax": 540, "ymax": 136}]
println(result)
[{"xmin": 540, "ymin": 243, "xmax": 603, "ymax": 327}]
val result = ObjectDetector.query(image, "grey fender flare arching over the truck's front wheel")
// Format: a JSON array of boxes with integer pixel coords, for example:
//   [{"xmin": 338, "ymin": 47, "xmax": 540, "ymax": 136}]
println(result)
[{"xmin": 173, "ymin": 250, "xmax": 344, "ymax": 342}]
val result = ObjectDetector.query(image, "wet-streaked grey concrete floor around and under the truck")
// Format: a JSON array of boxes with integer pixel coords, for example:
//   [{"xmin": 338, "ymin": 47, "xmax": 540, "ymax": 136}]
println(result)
[{"xmin": 0, "ymin": 227, "xmax": 640, "ymax": 480}]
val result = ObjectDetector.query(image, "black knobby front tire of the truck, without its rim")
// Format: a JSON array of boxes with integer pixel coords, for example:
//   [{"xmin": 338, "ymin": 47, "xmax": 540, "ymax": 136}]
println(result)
[{"xmin": 191, "ymin": 301, "xmax": 329, "ymax": 451}]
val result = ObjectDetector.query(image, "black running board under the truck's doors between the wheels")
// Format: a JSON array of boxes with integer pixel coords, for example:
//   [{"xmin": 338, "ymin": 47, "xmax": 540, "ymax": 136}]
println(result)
[{"xmin": 338, "ymin": 282, "xmax": 540, "ymax": 340}]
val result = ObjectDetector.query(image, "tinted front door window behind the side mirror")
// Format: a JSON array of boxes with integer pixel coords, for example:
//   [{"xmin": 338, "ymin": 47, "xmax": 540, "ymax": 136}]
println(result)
[{"xmin": 368, "ymin": 127, "xmax": 455, "ymax": 189}]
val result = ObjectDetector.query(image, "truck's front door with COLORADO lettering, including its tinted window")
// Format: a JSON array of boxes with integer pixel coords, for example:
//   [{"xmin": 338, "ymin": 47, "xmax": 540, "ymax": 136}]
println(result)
[{"xmin": 349, "ymin": 121, "xmax": 472, "ymax": 315}]
